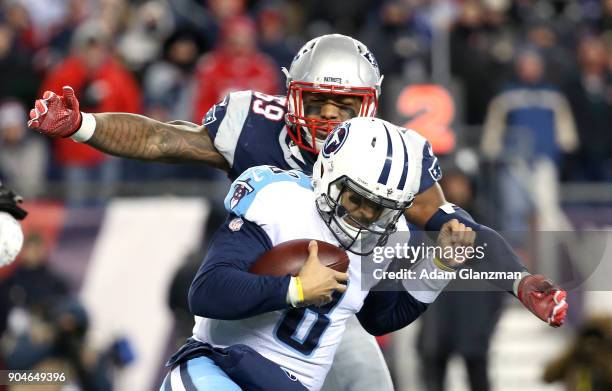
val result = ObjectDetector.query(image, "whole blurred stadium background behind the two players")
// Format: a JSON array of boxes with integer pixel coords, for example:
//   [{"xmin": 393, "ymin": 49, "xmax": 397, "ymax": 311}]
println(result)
[{"xmin": 0, "ymin": 0, "xmax": 612, "ymax": 391}]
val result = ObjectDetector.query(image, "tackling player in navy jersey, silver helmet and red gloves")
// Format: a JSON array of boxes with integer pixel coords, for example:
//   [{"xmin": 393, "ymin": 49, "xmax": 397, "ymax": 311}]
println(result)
[{"xmin": 28, "ymin": 34, "xmax": 564, "ymax": 391}]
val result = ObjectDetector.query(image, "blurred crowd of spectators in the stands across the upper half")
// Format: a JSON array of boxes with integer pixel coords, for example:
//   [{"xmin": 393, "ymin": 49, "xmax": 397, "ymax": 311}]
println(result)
[{"xmin": 0, "ymin": 0, "xmax": 612, "ymax": 199}]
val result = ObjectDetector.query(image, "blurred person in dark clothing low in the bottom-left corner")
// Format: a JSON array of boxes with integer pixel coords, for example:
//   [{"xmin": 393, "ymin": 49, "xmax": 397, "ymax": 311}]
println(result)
[{"xmin": 0, "ymin": 233, "xmax": 125, "ymax": 391}]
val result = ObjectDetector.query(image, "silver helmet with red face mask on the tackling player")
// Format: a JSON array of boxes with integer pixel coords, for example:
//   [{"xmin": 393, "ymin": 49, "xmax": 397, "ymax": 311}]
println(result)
[{"xmin": 283, "ymin": 34, "xmax": 383, "ymax": 153}]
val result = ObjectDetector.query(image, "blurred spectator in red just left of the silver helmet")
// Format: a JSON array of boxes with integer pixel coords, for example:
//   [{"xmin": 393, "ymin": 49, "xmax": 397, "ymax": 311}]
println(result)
[{"xmin": 193, "ymin": 16, "xmax": 279, "ymax": 123}]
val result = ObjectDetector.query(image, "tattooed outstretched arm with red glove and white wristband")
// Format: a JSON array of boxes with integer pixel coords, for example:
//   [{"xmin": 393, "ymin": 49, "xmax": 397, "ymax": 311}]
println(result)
[{"xmin": 28, "ymin": 87, "xmax": 229, "ymax": 170}]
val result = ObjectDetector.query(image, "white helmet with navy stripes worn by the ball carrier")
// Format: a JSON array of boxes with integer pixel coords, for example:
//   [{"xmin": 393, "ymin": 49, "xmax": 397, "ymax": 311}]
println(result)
[{"xmin": 312, "ymin": 117, "xmax": 414, "ymax": 255}]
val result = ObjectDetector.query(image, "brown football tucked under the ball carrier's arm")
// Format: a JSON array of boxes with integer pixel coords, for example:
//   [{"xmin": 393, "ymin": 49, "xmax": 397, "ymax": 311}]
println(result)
[{"xmin": 249, "ymin": 239, "xmax": 349, "ymax": 277}]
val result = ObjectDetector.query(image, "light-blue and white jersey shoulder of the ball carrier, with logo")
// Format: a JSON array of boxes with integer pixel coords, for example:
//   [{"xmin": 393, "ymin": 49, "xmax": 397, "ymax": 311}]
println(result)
[{"xmin": 224, "ymin": 166, "xmax": 312, "ymax": 224}]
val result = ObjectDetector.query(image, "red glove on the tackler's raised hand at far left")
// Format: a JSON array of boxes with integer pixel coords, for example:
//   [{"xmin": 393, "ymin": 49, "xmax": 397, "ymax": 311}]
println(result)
[{"xmin": 28, "ymin": 86, "xmax": 82, "ymax": 137}]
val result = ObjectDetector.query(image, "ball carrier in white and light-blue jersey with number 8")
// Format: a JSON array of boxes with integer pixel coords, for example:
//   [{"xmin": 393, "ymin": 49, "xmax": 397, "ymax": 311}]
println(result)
[{"xmin": 161, "ymin": 118, "xmax": 475, "ymax": 391}]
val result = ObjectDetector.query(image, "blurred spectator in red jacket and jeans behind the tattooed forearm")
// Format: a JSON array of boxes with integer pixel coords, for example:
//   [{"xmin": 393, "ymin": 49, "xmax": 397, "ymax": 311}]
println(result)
[{"xmin": 42, "ymin": 21, "xmax": 141, "ymax": 205}]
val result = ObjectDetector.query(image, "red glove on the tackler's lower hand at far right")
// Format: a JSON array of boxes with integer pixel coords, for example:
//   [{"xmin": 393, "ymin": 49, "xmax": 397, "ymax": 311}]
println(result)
[{"xmin": 518, "ymin": 274, "xmax": 567, "ymax": 327}]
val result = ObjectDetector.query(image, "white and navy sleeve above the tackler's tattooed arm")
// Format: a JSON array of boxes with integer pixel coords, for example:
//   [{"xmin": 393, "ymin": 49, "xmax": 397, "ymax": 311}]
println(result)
[{"xmin": 202, "ymin": 90, "xmax": 253, "ymax": 167}]
